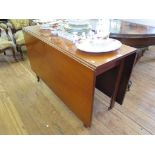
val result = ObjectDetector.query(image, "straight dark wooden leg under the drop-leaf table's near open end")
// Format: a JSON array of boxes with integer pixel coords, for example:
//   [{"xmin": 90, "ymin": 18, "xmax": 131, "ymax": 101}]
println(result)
[{"xmin": 108, "ymin": 59, "xmax": 124, "ymax": 110}]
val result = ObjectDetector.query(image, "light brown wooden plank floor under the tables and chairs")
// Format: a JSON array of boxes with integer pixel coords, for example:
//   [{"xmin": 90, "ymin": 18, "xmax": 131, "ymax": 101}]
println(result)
[{"xmin": 0, "ymin": 47, "xmax": 155, "ymax": 135}]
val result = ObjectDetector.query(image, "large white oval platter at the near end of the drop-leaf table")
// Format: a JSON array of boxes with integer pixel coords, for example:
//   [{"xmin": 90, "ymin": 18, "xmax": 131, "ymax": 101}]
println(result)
[{"xmin": 76, "ymin": 38, "xmax": 122, "ymax": 53}]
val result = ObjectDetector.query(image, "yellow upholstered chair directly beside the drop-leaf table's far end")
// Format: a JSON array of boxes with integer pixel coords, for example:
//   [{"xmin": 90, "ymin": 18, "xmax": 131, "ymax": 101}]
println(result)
[{"xmin": 7, "ymin": 19, "xmax": 30, "ymax": 59}]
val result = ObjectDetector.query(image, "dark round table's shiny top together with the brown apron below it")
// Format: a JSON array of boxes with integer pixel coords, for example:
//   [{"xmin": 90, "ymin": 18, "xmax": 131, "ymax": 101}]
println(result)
[{"xmin": 110, "ymin": 19, "xmax": 155, "ymax": 48}]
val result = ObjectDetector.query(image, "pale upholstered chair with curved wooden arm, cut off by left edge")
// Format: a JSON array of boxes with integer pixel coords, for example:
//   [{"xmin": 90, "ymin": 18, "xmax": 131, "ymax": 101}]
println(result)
[{"xmin": 0, "ymin": 24, "xmax": 17, "ymax": 61}]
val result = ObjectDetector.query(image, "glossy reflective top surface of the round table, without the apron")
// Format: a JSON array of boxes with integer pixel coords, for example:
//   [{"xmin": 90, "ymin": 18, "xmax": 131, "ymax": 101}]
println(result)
[{"xmin": 110, "ymin": 19, "xmax": 155, "ymax": 38}]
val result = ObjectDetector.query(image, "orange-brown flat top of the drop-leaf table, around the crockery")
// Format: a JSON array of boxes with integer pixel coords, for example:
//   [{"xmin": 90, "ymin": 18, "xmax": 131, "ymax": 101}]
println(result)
[{"xmin": 24, "ymin": 25, "xmax": 136, "ymax": 70}]
